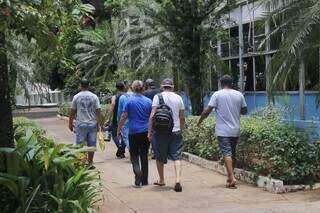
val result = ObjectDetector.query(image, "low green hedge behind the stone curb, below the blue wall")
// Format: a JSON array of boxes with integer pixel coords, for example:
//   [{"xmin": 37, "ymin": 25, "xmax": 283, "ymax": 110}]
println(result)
[{"xmin": 184, "ymin": 112, "xmax": 320, "ymax": 184}]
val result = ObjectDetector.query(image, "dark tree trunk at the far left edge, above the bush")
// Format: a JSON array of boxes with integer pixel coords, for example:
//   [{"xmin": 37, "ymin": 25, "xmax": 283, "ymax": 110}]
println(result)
[{"xmin": 0, "ymin": 32, "xmax": 14, "ymax": 147}]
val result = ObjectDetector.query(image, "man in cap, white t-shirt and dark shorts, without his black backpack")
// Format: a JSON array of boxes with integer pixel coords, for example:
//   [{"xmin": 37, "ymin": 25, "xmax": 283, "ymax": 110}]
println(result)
[{"xmin": 148, "ymin": 79, "xmax": 185, "ymax": 192}]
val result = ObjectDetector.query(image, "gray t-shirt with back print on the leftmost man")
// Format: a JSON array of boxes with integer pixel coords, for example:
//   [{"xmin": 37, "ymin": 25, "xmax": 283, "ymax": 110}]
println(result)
[{"xmin": 71, "ymin": 91, "xmax": 101, "ymax": 124}]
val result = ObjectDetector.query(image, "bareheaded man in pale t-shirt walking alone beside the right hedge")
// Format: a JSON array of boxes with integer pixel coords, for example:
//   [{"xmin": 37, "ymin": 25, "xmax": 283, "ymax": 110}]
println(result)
[{"xmin": 198, "ymin": 75, "xmax": 247, "ymax": 188}]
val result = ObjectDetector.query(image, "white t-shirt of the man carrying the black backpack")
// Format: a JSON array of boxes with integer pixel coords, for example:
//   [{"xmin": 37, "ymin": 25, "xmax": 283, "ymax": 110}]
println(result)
[{"xmin": 152, "ymin": 91, "xmax": 184, "ymax": 132}]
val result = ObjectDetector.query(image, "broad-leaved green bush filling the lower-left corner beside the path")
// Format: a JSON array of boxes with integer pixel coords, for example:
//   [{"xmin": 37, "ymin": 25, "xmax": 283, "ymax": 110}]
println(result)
[{"xmin": 0, "ymin": 119, "xmax": 102, "ymax": 212}]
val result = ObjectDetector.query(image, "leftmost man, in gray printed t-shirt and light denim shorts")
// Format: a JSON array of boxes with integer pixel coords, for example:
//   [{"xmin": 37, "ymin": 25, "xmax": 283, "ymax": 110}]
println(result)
[{"xmin": 69, "ymin": 79, "xmax": 102, "ymax": 169}]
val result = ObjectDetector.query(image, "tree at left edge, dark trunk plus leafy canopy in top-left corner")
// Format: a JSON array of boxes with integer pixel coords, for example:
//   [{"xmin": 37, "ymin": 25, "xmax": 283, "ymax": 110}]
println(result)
[{"xmin": 0, "ymin": 0, "xmax": 89, "ymax": 147}]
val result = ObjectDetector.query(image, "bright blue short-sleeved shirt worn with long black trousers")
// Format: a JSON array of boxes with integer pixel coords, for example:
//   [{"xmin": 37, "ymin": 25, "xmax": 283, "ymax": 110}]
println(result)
[{"xmin": 123, "ymin": 94, "xmax": 152, "ymax": 134}]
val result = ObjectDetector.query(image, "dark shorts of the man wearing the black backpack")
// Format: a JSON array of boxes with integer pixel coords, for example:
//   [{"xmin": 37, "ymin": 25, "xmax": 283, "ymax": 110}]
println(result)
[{"xmin": 154, "ymin": 131, "xmax": 183, "ymax": 164}]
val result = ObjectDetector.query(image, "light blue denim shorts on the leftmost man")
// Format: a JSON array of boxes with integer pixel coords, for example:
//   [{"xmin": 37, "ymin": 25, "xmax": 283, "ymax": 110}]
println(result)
[{"xmin": 76, "ymin": 123, "xmax": 97, "ymax": 147}]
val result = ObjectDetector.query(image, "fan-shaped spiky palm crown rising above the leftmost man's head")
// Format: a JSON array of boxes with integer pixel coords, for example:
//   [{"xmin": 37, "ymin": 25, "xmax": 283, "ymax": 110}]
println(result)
[{"xmin": 74, "ymin": 22, "xmax": 126, "ymax": 79}]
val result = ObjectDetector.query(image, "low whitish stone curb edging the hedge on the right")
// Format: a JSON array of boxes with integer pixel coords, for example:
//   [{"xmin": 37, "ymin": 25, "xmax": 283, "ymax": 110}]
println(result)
[{"xmin": 182, "ymin": 152, "xmax": 320, "ymax": 194}]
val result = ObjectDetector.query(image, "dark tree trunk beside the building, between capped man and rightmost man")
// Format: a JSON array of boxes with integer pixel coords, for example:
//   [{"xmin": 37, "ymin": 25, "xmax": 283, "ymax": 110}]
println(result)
[{"xmin": 185, "ymin": 28, "xmax": 203, "ymax": 115}]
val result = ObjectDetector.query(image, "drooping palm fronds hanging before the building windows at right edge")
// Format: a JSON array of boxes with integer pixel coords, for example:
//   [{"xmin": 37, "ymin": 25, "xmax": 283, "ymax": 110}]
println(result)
[{"xmin": 263, "ymin": 0, "xmax": 320, "ymax": 119}]
